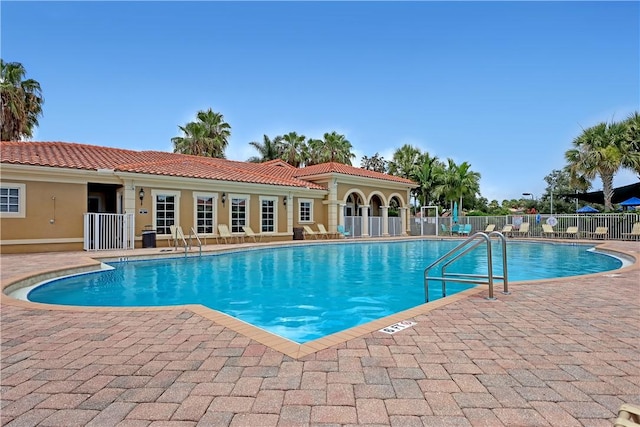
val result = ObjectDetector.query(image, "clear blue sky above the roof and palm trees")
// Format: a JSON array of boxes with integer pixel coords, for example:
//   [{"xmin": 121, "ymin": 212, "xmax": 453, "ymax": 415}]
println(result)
[{"xmin": 0, "ymin": 0, "xmax": 640, "ymax": 201}]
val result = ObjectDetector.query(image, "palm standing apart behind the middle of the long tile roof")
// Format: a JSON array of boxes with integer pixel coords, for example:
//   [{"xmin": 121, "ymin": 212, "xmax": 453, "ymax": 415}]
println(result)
[{"xmin": 171, "ymin": 108, "xmax": 231, "ymax": 159}]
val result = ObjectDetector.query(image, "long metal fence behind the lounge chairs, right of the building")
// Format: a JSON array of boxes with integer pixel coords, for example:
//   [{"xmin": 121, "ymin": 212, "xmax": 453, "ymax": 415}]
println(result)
[{"xmin": 411, "ymin": 213, "xmax": 640, "ymax": 240}]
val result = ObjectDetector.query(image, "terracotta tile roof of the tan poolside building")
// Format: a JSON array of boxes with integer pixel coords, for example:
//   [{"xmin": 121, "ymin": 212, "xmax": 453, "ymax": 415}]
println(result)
[{"xmin": 0, "ymin": 141, "xmax": 414, "ymax": 190}]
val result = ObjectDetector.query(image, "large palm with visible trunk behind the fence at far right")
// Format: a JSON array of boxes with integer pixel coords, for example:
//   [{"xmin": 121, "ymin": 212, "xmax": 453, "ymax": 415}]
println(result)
[{"xmin": 565, "ymin": 122, "xmax": 640, "ymax": 211}]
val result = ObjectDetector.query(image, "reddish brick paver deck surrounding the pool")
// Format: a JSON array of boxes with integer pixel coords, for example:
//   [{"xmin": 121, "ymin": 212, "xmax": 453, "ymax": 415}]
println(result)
[{"xmin": 0, "ymin": 242, "xmax": 640, "ymax": 427}]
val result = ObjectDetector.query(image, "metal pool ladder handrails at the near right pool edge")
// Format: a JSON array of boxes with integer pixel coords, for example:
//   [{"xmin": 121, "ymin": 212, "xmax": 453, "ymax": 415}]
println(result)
[{"xmin": 424, "ymin": 231, "xmax": 509, "ymax": 302}]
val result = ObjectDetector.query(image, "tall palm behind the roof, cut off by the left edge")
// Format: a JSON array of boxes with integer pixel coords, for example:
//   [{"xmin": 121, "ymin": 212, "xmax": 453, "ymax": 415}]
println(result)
[{"xmin": 0, "ymin": 59, "xmax": 44, "ymax": 141}]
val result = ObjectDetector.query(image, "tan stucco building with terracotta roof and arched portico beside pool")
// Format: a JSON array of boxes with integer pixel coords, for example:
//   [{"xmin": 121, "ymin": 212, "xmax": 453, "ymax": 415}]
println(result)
[{"xmin": 0, "ymin": 142, "xmax": 416, "ymax": 253}]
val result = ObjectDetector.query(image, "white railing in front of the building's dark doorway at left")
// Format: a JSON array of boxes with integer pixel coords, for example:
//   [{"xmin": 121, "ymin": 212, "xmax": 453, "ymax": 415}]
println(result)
[{"xmin": 84, "ymin": 213, "xmax": 135, "ymax": 251}]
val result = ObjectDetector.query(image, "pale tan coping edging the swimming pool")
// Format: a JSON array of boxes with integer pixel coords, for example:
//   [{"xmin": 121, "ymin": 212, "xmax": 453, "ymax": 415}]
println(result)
[{"xmin": 0, "ymin": 236, "xmax": 640, "ymax": 359}]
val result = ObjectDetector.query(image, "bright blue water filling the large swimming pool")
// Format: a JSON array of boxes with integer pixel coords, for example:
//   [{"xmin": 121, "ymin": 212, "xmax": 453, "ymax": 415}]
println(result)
[{"xmin": 28, "ymin": 240, "xmax": 622, "ymax": 343}]
